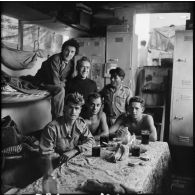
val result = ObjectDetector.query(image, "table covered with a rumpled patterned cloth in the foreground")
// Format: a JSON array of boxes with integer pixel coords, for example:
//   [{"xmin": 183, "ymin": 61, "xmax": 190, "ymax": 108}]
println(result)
[{"xmin": 17, "ymin": 141, "xmax": 171, "ymax": 194}]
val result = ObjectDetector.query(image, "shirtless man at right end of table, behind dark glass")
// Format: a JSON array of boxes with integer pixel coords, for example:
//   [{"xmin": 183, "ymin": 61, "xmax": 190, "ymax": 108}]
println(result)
[{"xmin": 110, "ymin": 96, "xmax": 157, "ymax": 141}]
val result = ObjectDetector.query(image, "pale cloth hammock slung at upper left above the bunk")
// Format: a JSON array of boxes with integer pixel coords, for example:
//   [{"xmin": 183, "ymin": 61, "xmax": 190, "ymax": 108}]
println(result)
[{"xmin": 1, "ymin": 43, "xmax": 47, "ymax": 70}]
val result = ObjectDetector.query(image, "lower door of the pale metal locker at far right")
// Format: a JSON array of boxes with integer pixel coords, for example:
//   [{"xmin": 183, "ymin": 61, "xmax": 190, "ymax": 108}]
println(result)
[{"xmin": 170, "ymin": 88, "xmax": 193, "ymax": 146}]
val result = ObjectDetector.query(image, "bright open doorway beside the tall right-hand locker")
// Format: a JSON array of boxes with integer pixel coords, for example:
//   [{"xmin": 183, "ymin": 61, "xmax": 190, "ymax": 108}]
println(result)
[{"xmin": 135, "ymin": 13, "xmax": 190, "ymax": 67}]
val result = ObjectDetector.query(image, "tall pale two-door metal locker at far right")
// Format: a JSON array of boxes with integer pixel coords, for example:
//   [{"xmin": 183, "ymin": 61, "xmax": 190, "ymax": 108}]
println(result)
[{"xmin": 169, "ymin": 30, "xmax": 193, "ymax": 146}]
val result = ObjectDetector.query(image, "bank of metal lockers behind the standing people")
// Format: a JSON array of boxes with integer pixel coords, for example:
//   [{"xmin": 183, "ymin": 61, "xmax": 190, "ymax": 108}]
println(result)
[{"xmin": 75, "ymin": 28, "xmax": 137, "ymax": 91}]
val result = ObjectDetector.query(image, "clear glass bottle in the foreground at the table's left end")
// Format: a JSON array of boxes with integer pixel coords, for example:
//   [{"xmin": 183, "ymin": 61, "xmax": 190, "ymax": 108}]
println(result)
[{"xmin": 42, "ymin": 156, "xmax": 58, "ymax": 194}]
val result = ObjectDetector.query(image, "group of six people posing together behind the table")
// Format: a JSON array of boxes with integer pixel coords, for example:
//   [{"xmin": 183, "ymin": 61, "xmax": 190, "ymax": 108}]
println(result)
[{"xmin": 28, "ymin": 39, "xmax": 157, "ymax": 163}]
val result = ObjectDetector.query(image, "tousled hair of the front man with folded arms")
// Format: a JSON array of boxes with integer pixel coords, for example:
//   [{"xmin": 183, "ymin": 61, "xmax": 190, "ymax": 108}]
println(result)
[{"xmin": 64, "ymin": 92, "xmax": 85, "ymax": 106}]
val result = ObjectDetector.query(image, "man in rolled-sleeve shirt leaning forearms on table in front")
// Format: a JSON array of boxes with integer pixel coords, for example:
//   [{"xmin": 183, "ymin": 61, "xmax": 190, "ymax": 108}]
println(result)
[{"xmin": 40, "ymin": 93, "xmax": 94, "ymax": 164}]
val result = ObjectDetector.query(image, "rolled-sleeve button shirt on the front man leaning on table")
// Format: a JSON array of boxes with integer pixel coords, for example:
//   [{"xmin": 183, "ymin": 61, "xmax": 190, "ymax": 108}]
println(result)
[{"xmin": 40, "ymin": 116, "xmax": 94, "ymax": 155}]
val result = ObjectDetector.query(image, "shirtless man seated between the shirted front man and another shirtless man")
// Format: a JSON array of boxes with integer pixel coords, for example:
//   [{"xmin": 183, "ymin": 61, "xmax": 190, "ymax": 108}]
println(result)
[{"xmin": 81, "ymin": 93, "xmax": 109, "ymax": 141}]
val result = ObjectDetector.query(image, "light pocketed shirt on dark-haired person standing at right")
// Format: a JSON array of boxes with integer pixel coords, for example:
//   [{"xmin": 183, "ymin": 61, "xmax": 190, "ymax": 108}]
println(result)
[{"xmin": 100, "ymin": 84, "xmax": 132, "ymax": 118}]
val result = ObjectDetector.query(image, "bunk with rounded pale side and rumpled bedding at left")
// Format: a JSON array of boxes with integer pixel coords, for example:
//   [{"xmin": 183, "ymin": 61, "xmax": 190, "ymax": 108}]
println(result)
[{"xmin": 1, "ymin": 72, "xmax": 52, "ymax": 135}]
